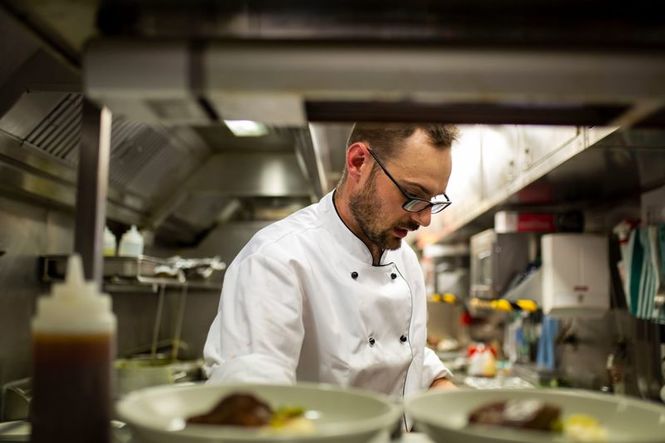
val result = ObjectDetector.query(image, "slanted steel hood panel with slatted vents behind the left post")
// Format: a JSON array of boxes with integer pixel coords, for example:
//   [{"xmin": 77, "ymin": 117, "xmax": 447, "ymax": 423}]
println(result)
[{"xmin": 0, "ymin": 92, "xmax": 209, "ymax": 211}]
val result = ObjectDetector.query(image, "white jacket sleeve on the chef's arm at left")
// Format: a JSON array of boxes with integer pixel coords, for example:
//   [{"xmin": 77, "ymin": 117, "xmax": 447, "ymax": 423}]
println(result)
[{"xmin": 203, "ymin": 251, "xmax": 304, "ymax": 383}]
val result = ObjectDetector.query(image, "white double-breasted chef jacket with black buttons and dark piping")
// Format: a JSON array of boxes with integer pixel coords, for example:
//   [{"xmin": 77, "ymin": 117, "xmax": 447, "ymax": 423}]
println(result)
[{"xmin": 204, "ymin": 192, "xmax": 450, "ymax": 397}]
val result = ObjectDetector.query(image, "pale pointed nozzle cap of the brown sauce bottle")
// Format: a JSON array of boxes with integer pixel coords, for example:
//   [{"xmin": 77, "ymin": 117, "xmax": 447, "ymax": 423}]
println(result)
[{"xmin": 33, "ymin": 254, "xmax": 115, "ymax": 332}]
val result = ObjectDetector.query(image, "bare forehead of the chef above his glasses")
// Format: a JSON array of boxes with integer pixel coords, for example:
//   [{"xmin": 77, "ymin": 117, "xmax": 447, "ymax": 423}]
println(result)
[{"xmin": 386, "ymin": 130, "xmax": 451, "ymax": 195}]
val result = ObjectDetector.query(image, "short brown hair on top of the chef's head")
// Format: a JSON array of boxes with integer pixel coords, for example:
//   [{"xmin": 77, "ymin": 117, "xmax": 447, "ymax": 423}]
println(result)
[{"xmin": 346, "ymin": 122, "xmax": 459, "ymax": 160}]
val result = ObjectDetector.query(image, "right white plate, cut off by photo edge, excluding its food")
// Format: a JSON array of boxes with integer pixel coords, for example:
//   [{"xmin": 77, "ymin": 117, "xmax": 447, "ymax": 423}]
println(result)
[{"xmin": 405, "ymin": 389, "xmax": 665, "ymax": 443}]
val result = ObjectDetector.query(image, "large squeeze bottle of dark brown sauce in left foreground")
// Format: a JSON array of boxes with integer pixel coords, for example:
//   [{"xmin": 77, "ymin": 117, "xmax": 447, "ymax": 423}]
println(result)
[{"xmin": 31, "ymin": 255, "xmax": 116, "ymax": 443}]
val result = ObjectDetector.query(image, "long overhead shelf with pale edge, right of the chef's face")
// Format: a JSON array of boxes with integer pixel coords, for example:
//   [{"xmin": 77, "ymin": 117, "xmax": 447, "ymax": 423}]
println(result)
[{"xmin": 428, "ymin": 128, "xmax": 665, "ymax": 243}]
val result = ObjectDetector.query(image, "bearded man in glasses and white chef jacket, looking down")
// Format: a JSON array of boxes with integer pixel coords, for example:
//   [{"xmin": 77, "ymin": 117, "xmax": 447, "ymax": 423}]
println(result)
[{"xmin": 204, "ymin": 123, "xmax": 457, "ymax": 398}]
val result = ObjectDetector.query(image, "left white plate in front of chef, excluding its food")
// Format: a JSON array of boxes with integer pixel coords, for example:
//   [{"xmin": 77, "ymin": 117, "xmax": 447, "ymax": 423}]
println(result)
[{"xmin": 117, "ymin": 383, "xmax": 401, "ymax": 443}]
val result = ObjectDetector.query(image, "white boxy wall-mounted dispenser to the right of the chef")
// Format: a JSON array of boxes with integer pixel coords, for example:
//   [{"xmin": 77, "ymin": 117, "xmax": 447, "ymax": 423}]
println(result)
[{"xmin": 541, "ymin": 233, "xmax": 610, "ymax": 316}]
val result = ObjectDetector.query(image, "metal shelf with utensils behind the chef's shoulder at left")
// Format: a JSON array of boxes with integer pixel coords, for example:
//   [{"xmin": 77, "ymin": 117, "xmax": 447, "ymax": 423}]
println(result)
[{"xmin": 39, "ymin": 255, "xmax": 225, "ymax": 292}]
